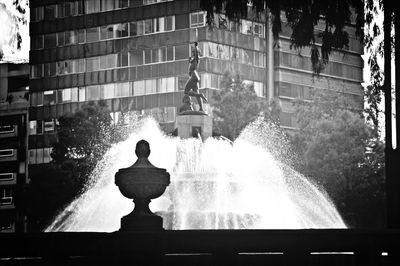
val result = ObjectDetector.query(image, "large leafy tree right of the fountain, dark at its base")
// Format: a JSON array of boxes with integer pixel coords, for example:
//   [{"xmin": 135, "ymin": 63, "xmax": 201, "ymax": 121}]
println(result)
[{"xmin": 292, "ymin": 92, "xmax": 384, "ymax": 227}]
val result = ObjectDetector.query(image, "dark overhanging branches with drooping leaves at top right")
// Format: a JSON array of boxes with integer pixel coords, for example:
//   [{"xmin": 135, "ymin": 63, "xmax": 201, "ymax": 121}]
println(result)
[{"xmin": 200, "ymin": 0, "xmax": 364, "ymax": 73}]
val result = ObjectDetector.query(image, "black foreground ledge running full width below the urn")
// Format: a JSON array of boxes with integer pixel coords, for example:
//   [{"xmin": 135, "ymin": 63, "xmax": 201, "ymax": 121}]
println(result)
[{"xmin": 0, "ymin": 229, "xmax": 400, "ymax": 266}]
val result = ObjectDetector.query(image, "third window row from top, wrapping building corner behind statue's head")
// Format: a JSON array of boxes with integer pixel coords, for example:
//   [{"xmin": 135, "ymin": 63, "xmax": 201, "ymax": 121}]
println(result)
[{"xmin": 30, "ymin": 42, "xmax": 265, "ymax": 78}]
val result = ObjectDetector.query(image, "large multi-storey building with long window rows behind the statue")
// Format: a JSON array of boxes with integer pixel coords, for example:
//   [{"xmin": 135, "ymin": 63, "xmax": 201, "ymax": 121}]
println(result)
[{"xmin": 29, "ymin": 0, "xmax": 363, "ymax": 156}]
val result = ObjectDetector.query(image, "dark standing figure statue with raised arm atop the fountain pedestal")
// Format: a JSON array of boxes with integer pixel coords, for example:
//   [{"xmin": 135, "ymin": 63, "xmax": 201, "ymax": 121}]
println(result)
[{"xmin": 181, "ymin": 42, "xmax": 207, "ymax": 111}]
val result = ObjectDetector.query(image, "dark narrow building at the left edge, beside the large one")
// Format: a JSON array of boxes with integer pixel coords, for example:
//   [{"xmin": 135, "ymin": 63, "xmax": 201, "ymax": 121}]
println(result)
[{"xmin": 0, "ymin": 63, "xmax": 29, "ymax": 232}]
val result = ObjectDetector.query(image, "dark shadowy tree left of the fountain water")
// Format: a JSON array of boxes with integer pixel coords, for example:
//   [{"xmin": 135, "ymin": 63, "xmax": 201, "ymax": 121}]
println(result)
[{"xmin": 24, "ymin": 101, "xmax": 116, "ymax": 231}]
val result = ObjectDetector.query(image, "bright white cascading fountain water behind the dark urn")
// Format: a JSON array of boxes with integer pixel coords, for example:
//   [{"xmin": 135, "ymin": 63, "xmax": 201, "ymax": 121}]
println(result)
[{"xmin": 46, "ymin": 119, "xmax": 346, "ymax": 232}]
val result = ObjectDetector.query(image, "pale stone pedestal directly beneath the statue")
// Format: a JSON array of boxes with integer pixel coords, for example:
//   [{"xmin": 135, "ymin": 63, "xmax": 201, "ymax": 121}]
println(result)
[{"xmin": 175, "ymin": 111, "xmax": 212, "ymax": 141}]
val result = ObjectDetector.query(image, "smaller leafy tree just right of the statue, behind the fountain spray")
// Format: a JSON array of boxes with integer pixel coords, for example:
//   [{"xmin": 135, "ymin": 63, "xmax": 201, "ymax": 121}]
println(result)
[{"xmin": 213, "ymin": 73, "xmax": 279, "ymax": 140}]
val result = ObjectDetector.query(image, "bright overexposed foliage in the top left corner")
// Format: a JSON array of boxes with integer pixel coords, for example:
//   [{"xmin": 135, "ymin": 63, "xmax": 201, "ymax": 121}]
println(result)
[{"xmin": 0, "ymin": 0, "xmax": 29, "ymax": 61}]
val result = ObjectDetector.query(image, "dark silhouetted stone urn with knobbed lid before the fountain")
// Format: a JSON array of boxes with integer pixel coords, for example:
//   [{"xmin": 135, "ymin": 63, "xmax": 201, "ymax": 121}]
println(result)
[{"xmin": 115, "ymin": 140, "xmax": 170, "ymax": 231}]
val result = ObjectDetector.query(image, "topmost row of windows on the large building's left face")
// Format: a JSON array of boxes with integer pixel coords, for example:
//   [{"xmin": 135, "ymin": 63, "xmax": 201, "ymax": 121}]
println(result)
[{"xmin": 31, "ymin": 0, "xmax": 173, "ymax": 21}]
